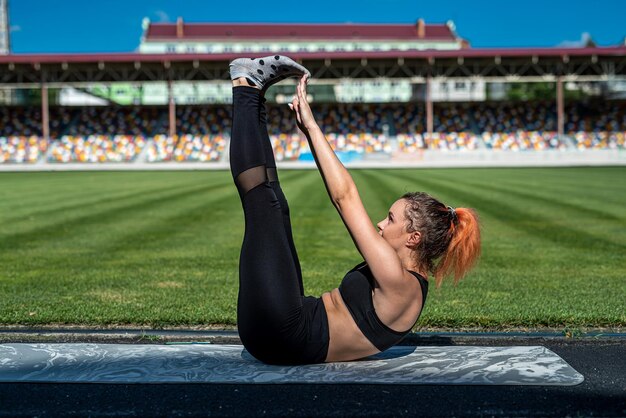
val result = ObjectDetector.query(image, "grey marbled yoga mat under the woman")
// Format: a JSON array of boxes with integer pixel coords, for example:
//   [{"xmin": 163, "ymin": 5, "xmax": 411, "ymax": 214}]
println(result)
[{"xmin": 0, "ymin": 343, "xmax": 584, "ymax": 386}]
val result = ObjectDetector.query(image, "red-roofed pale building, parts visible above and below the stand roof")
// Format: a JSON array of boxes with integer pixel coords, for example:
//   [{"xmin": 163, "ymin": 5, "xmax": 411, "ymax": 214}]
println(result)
[{"xmin": 138, "ymin": 18, "xmax": 485, "ymax": 103}]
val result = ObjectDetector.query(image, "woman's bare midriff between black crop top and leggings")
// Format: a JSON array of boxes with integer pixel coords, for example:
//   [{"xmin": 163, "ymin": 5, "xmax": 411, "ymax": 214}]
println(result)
[{"xmin": 322, "ymin": 289, "xmax": 380, "ymax": 362}]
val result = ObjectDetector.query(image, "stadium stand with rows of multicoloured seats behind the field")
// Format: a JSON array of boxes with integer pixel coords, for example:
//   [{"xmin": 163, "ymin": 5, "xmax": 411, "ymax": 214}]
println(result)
[{"xmin": 0, "ymin": 102, "xmax": 626, "ymax": 163}]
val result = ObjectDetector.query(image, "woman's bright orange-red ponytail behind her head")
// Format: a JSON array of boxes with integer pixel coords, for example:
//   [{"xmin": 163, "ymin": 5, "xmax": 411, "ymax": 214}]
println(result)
[{"xmin": 434, "ymin": 208, "xmax": 480, "ymax": 287}]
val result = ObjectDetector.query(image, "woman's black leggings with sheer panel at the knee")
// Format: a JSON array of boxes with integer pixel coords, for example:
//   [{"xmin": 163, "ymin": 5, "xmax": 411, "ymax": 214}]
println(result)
[{"xmin": 230, "ymin": 86, "xmax": 329, "ymax": 364}]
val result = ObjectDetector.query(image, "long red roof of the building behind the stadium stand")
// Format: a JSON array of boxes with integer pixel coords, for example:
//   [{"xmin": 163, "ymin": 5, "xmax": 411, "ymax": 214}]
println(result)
[{"xmin": 145, "ymin": 22, "xmax": 457, "ymax": 42}]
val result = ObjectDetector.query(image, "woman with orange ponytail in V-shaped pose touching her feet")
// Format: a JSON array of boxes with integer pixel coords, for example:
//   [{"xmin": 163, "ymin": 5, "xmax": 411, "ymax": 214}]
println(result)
[{"xmin": 230, "ymin": 55, "xmax": 480, "ymax": 364}]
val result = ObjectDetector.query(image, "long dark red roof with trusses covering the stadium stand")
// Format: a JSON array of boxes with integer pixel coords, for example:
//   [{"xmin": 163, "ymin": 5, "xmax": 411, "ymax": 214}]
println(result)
[{"xmin": 0, "ymin": 46, "xmax": 626, "ymax": 86}]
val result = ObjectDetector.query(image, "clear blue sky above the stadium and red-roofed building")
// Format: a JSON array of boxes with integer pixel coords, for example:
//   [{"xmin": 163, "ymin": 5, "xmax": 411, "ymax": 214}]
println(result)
[{"xmin": 9, "ymin": 0, "xmax": 626, "ymax": 53}]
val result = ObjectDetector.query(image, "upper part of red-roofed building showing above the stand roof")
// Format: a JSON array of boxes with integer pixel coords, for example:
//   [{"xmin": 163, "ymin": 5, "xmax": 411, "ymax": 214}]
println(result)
[{"xmin": 139, "ymin": 18, "xmax": 469, "ymax": 54}]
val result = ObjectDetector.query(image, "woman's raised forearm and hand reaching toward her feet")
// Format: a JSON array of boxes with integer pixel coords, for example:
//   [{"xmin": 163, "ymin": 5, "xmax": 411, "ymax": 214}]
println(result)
[{"xmin": 289, "ymin": 77, "xmax": 356, "ymax": 206}]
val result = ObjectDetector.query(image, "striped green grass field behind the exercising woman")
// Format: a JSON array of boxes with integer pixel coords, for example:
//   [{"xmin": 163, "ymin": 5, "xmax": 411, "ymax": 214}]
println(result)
[{"xmin": 0, "ymin": 167, "xmax": 626, "ymax": 329}]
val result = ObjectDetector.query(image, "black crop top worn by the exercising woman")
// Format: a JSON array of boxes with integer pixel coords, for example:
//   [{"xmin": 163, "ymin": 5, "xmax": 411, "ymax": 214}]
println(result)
[{"xmin": 339, "ymin": 261, "xmax": 428, "ymax": 351}]
